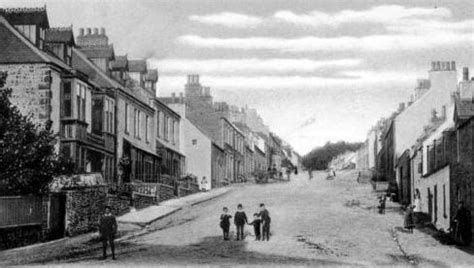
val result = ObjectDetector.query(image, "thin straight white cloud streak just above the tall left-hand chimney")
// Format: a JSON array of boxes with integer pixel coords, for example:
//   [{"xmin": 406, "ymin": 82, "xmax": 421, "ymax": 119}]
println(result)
[{"xmin": 151, "ymin": 58, "xmax": 362, "ymax": 75}]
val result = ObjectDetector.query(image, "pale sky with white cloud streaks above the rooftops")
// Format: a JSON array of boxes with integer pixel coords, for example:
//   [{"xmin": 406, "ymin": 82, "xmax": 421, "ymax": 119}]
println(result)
[{"xmin": 0, "ymin": 0, "xmax": 474, "ymax": 154}]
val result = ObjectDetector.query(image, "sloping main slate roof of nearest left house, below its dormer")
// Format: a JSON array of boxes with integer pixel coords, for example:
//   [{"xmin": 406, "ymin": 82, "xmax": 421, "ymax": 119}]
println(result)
[{"xmin": 0, "ymin": 15, "xmax": 71, "ymax": 70}]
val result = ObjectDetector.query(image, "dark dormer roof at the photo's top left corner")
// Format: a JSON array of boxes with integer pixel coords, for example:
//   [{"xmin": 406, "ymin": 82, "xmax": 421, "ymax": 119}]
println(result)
[{"xmin": 0, "ymin": 6, "xmax": 49, "ymax": 28}]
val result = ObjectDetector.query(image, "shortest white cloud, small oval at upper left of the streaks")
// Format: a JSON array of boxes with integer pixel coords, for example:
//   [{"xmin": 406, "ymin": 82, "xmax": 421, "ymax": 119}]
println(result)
[{"xmin": 189, "ymin": 12, "xmax": 263, "ymax": 28}]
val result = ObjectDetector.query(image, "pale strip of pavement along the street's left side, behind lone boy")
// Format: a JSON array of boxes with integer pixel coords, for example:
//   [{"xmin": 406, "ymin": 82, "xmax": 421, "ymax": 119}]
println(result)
[{"xmin": 117, "ymin": 188, "xmax": 230, "ymax": 227}]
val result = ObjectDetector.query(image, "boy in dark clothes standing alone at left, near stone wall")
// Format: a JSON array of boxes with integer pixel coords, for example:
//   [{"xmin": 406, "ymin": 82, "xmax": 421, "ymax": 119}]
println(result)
[{"xmin": 99, "ymin": 206, "xmax": 117, "ymax": 260}]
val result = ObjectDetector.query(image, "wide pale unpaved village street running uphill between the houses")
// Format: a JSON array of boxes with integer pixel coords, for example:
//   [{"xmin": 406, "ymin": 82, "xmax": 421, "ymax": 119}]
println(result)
[{"xmin": 0, "ymin": 171, "xmax": 474, "ymax": 266}]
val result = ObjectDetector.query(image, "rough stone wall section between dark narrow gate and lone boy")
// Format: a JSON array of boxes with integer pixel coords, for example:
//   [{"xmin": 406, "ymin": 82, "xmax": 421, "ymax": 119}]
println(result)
[{"xmin": 66, "ymin": 187, "xmax": 107, "ymax": 236}]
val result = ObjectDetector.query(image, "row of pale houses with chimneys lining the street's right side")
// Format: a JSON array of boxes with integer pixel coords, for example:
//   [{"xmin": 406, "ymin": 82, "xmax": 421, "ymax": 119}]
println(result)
[{"xmin": 358, "ymin": 61, "xmax": 474, "ymax": 234}]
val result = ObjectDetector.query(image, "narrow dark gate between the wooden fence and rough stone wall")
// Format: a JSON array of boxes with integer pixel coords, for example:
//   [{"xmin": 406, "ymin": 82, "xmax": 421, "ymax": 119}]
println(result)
[{"xmin": 48, "ymin": 193, "xmax": 66, "ymax": 239}]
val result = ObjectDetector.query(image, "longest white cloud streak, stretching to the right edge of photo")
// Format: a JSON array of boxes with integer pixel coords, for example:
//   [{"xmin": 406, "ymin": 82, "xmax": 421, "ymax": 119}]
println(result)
[{"xmin": 177, "ymin": 32, "xmax": 472, "ymax": 52}]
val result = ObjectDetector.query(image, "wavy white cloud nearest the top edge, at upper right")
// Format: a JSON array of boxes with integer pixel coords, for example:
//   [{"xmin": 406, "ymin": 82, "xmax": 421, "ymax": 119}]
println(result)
[{"xmin": 273, "ymin": 5, "xmax": 452, "ymax": 27}]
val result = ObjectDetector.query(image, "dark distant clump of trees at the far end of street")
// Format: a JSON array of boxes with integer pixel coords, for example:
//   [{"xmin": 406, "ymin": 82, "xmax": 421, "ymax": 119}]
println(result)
[{"xmin": 302, "ymin": 141, "xmax": 362, "ymax": 170}]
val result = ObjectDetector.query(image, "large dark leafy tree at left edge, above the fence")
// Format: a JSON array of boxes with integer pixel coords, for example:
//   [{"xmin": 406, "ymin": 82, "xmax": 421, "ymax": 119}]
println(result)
[{"xmin": 0, "ymin": 73, "xmax": 73, "ymax": 196}]
